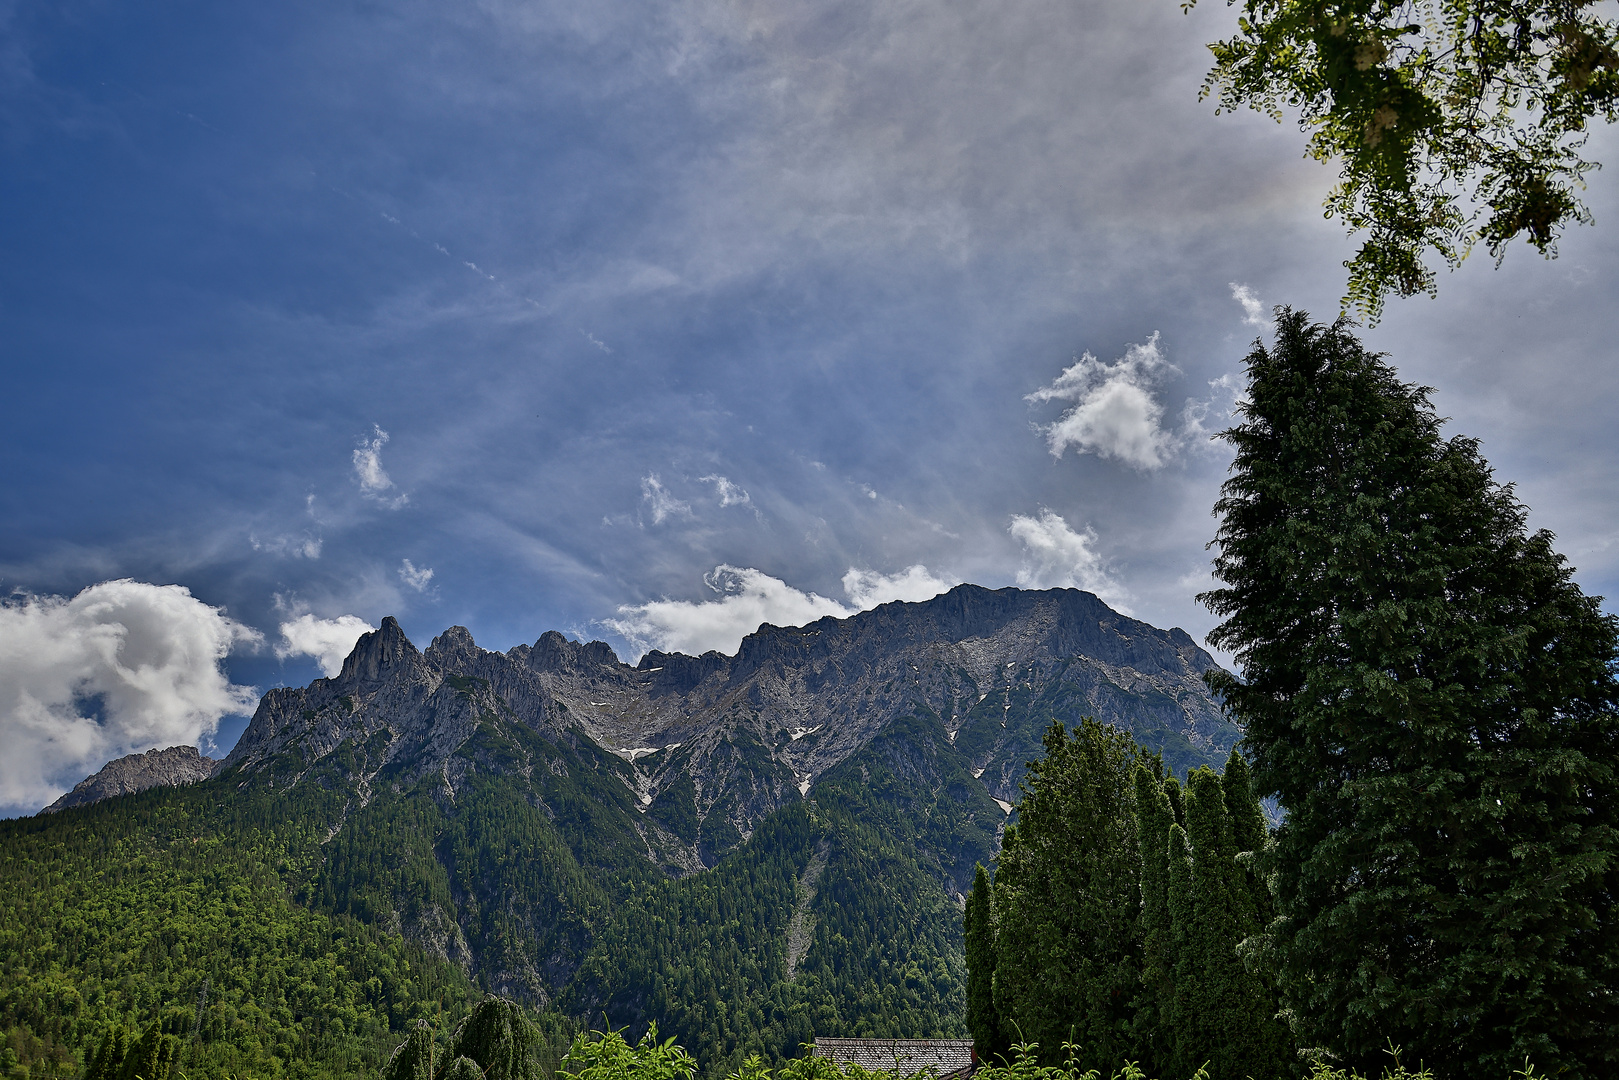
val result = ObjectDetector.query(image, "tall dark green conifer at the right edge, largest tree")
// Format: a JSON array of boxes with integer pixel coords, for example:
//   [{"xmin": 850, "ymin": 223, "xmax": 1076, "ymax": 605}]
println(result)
[{"xmin": 1205, "ymin": 309, "xmax": 1619, "ymax": 1077}]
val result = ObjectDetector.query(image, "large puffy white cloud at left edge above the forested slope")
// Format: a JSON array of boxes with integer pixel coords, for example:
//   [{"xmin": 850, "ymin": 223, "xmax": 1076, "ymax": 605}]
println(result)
[{"xmin": 0, "ymin": 578, "xmax": 262, "ymax": 806}]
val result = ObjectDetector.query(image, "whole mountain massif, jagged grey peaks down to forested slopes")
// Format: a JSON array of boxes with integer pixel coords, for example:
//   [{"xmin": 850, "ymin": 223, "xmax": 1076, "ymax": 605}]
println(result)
[{"xmin": 0, "ymin": 586, "xmax": 1237, "ymax": 1072}]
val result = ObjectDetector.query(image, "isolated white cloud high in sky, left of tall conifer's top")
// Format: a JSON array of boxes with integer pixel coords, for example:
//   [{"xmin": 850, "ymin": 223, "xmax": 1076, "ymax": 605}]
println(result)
[{"xmin": 1025, "ymin": 332, "xmax": 1179, "ymax": 470}]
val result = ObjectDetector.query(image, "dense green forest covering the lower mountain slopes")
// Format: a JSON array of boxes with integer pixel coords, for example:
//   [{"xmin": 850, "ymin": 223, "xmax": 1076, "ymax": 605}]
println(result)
[{"xmin": 0, "ymin": 705, "xmax": 977, "ymax": 1080}]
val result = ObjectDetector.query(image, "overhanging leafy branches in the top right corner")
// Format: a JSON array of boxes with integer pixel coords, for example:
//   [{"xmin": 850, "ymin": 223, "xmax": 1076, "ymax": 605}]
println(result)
[{"xmin": 1183, "ymin": 0, "xmax": 1619, "ymax": 321}]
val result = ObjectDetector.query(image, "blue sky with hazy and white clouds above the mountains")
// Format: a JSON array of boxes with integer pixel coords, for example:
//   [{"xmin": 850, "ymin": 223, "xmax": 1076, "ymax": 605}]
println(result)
[{"xmin": 0, "ymin": 0, "xmax": 1619, "ymax": 813}]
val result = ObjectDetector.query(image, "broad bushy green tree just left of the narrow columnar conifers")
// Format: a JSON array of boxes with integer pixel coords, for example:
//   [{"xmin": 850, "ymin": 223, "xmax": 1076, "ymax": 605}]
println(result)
[{"xmin": 996, "ymin": 719, "xmax": 1161, "ymax": 1067}]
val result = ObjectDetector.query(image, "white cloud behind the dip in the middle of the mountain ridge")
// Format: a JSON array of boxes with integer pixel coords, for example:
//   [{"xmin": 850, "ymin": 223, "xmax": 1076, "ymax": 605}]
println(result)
[{"xmin": 604, "ymin": 563, "xmax": 853, "ymax": 656}]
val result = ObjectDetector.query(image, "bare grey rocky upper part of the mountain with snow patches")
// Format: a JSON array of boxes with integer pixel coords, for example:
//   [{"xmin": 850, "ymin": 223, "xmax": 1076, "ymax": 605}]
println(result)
[{"xmin": 215, "ymin": 585, "xmax": 1239, "ymax": 865}]
